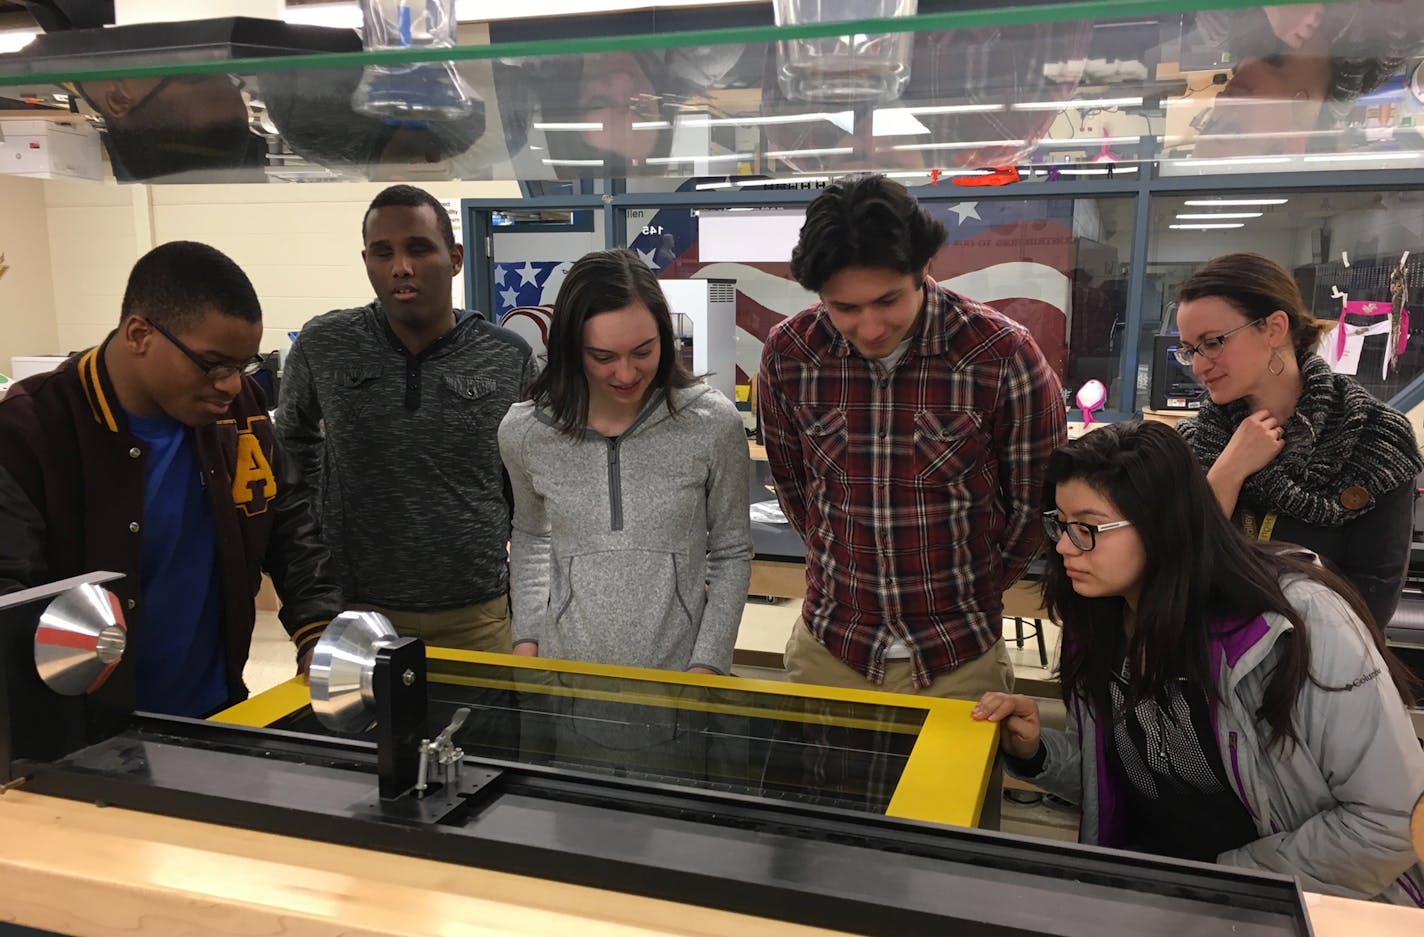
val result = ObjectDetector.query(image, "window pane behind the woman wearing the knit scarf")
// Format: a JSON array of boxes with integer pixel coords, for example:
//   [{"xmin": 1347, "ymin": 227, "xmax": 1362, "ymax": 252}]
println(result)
[{"xmin": 1139, "ymin": 191, "xmax": 1424, "ymax": 406}]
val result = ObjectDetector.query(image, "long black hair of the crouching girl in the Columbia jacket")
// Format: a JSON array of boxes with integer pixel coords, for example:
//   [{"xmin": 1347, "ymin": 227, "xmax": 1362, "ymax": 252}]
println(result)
[{"xmin": 1044, "ymin": 423, "xmax": 1417, "ymax": 743}]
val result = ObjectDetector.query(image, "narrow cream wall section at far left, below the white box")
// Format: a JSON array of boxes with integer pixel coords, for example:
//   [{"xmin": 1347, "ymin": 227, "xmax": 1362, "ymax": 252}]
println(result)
[{"xmin": 0, "ymin": 175, "xmax": 60, "ymax": 375}]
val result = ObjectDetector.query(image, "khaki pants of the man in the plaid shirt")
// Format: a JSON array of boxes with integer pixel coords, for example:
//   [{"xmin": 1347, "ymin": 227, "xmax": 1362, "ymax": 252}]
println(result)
[{"xmin": 782, "ymin": 618, "xmax": 1014, "ymax": 830}]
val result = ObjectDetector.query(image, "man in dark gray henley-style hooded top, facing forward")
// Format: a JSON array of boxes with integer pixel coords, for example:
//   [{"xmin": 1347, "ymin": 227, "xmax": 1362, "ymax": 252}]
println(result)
[{"xmin": 276, "ymin": 185, "xmax": 533, "ymax": 652}]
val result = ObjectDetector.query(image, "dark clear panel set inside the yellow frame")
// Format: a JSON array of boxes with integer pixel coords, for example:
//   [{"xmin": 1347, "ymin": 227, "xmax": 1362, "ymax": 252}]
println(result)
[{"xmin": 273, "ymin": 659, "xmax": 926, "ymax": 813}]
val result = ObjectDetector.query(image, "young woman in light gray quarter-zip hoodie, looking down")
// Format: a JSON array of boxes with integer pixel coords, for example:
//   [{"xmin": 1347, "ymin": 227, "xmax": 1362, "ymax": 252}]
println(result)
[{"xmin": 500, "ymin": 251, "xmax": 752, "ymax": 674}]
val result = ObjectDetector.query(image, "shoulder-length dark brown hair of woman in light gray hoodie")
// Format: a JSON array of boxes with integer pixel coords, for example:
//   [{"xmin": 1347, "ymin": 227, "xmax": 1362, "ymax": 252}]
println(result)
[{"xmin": 530, "ymin": 248, "xmax": 696, "ymax": 436}]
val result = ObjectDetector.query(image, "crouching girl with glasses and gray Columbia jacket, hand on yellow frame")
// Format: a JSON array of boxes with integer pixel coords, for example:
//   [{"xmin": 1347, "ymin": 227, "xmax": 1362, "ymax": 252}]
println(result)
[{"xmin": 974, "ymin": 423, "xmax": 1424, "ymax": 907}]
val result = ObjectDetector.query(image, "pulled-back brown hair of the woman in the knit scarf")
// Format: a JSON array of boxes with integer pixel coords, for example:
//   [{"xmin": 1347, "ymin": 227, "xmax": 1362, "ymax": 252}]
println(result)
[{"xmin": 1176, "ymin": 253, "xmax": 1330, "ymax": 360}]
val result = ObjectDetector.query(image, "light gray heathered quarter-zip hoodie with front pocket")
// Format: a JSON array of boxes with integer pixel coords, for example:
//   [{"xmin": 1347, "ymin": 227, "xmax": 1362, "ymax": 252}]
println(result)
[{"xmin": 500, "ymin": 383, "xmax": 752, "ymax": 674}]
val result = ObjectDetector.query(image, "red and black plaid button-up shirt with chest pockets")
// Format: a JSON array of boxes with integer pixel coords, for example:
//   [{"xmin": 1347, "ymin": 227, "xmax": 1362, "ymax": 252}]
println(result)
[{"xmin": 758, "ymin": 281, "xmax": 1067, "ymax": 686}]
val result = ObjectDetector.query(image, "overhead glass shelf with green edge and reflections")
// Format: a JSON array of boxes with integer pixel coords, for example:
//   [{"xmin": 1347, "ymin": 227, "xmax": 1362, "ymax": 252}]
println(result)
[{"xmin": 0, "ymin": 0, "xmax": 1424, "ymax": 181}]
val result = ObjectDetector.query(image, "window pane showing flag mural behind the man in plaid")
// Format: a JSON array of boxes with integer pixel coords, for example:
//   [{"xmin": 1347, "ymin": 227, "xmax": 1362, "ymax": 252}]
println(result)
[{"xmin": 624, "ymin": 192, "xmax": 1132, "ymax": 406}]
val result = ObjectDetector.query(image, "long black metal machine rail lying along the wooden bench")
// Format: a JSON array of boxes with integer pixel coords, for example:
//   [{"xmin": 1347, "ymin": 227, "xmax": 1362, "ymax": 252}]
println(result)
[{"xmin": 0, "ymin": 575, "xmax": 1312, "ymax": 937}]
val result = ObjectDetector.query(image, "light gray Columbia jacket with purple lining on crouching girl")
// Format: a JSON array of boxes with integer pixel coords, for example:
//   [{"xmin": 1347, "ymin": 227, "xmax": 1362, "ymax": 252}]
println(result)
[{"xmin": 1027, "ymin": 575, "xmax": 1424, "ymax": 907}]
